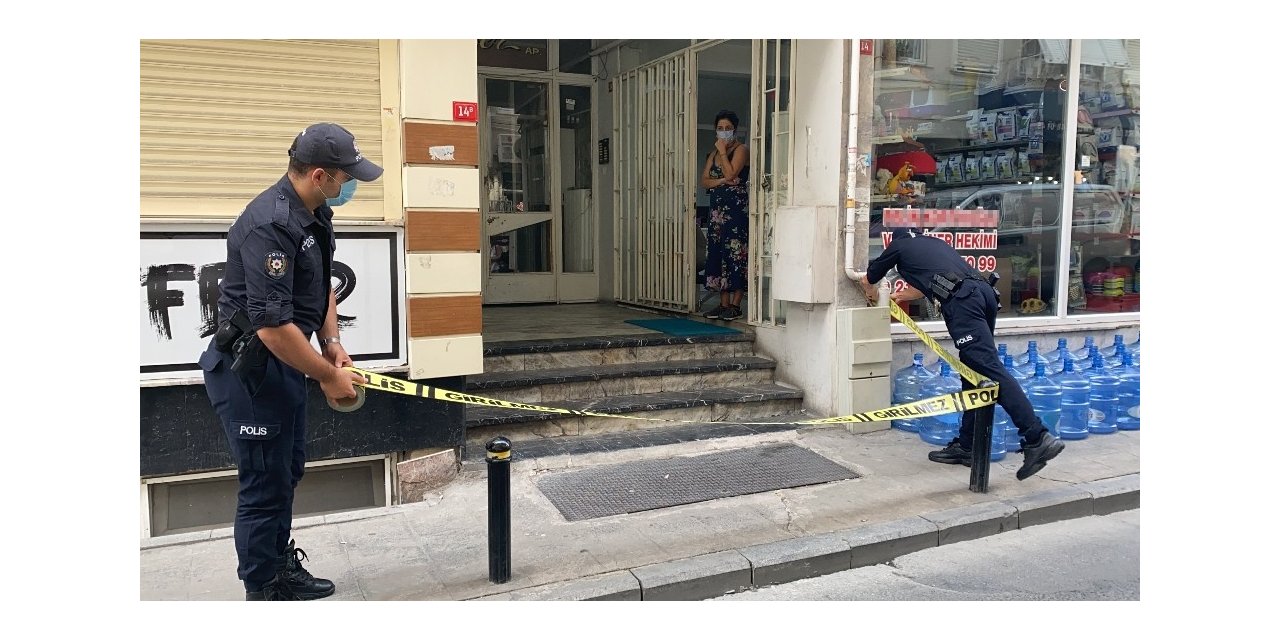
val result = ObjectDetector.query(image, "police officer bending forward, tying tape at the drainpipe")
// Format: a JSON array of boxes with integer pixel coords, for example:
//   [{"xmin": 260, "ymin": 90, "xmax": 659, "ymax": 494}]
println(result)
[{"xmin": 859, "ymin": 229, "xmax": 1065, "ymax": 480}]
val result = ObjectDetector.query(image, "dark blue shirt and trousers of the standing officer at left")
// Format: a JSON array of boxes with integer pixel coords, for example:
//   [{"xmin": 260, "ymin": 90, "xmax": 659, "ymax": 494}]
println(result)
[{"xmin": 200, "ymin": 174, "xmax": 335, "ymax": 591}]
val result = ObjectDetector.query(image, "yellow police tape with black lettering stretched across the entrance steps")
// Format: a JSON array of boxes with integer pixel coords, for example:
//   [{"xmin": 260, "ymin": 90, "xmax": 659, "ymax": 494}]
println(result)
[{"xmin": 347, "ymin": 301, "xmax": 1000, "ymax": 425}]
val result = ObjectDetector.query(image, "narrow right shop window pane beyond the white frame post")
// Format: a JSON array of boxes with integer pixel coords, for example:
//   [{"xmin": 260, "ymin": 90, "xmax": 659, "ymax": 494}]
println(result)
[{"xmin": 1068, "ymin": 40, "xmax": 1142, "ymax": 315}]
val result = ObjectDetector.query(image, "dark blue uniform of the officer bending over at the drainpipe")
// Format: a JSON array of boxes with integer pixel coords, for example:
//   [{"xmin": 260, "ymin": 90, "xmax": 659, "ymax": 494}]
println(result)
[{"xmin": 867, "ymin": 229, "xmax": 1056, "ymax": 458}]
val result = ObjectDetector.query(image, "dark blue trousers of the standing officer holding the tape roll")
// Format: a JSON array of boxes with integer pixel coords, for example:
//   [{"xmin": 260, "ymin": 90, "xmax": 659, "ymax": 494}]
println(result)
[{"xmin": 200, "ymin": 346, "xmax": 306, "ymax": 591}]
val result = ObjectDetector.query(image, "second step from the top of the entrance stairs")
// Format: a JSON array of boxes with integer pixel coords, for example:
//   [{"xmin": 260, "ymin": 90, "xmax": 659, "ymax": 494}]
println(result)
[{"xmin": 467, "ymin": 356, "xmax": 776, "ymax": 404}]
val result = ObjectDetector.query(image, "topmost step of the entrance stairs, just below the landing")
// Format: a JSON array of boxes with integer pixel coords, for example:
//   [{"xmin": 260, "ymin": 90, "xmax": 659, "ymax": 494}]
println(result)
[{"xmin": 484, "ymin": 333, "xmax": 755, "ymax": 374}]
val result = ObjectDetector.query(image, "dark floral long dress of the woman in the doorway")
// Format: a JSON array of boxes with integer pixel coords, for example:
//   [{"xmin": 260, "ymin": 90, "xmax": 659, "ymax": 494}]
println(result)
[{"xmin": 705, "ymin": 148, "xmax": 750, "ymax": 292}]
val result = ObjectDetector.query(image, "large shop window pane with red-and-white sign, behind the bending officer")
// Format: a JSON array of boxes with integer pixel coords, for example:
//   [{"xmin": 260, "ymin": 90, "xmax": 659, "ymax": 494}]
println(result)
[{"xmin": 870, "ymin": 40, "xmax": 1070, "ymax": 320}]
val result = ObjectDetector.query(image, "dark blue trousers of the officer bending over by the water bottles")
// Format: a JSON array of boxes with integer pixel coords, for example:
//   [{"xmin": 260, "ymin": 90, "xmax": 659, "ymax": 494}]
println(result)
[{"xmin": 942, "ymin": 279, "xmax": 1046, "ymax": 448}]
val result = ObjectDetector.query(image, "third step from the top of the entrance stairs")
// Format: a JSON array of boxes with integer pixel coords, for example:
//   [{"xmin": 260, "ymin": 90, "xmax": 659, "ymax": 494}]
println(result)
[{"xmin": 466, "ymin": 383, "xmax": 804, "ymax": 452}]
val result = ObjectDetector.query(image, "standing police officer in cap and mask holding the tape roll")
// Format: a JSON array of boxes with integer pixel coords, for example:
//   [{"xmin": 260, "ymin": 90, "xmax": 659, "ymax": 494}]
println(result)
[{"xmin": 200, "ymin": 123, "xmax": 383, "ymax": 600}]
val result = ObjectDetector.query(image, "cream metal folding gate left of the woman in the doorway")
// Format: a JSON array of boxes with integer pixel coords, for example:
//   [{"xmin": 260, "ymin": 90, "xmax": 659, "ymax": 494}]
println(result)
[{"xmin": 613, "ymin": 50, "xmax": 698, "ymax": 312}]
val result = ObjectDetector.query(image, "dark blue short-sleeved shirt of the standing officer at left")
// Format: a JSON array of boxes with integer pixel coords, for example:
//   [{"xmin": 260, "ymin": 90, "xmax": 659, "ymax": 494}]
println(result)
[{"xmin": 218, "ymin": 174, "xmax": 335, "ymax": 338}]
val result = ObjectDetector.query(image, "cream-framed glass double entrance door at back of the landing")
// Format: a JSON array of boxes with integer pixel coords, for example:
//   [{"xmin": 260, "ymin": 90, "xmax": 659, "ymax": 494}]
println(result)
[{"xmin": 480, "ymin": 78, "xmax": 599, "ymax": 303}]
